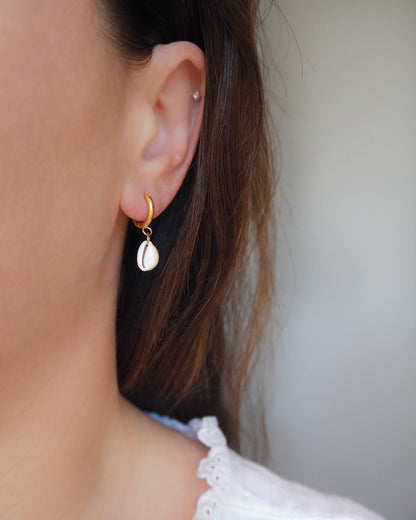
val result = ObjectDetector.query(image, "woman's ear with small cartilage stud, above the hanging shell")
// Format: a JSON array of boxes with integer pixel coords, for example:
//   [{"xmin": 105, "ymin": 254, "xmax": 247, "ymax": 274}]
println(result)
[{"xmin": 120, "ymin": 42, "xmax": 205, "ymax": 220}]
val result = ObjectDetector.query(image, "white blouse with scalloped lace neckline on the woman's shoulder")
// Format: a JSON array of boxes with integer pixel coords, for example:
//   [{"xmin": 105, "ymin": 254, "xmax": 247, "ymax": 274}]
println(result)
[{"xmin": 149, "ymin": 412, "xmax": 383, "ymax": 520}]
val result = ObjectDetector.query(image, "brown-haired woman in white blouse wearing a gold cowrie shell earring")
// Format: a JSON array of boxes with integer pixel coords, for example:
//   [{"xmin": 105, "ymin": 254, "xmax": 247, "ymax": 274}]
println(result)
[{"xmin": 0, "ymin": 0, "xmax": 386, "ymax": 520}]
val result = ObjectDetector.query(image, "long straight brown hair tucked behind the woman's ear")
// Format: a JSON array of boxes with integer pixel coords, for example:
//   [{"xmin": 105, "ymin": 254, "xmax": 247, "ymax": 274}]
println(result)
[{"xmin": 99, "ymin": 0, "xmax": 276, "ymax": 449}]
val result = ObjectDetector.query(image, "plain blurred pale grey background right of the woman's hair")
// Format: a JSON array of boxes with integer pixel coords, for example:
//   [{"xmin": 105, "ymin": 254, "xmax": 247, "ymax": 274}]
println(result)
[{"xmin": 265, "ymin": 0, "xmax": 416, "ymax": 520}]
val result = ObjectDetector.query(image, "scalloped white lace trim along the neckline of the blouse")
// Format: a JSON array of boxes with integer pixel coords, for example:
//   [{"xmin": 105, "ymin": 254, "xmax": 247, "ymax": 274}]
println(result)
[{"xmin": 189, "ymin": 416, "xmax": 230, "ymax": 520}]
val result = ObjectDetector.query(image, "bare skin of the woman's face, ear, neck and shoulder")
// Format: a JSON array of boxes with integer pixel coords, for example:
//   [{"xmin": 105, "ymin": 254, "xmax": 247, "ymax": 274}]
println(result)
[{"xmin": 0, "ymin": 0, "xmax": 206, "ymax": 520}]
